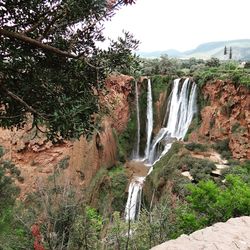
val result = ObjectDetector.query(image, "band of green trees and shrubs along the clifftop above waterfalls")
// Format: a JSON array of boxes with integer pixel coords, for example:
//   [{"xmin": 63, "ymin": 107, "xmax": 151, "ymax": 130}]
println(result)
[{"xmin": 143, "ymin": 55, "xmax": 250, "ymax": 90}]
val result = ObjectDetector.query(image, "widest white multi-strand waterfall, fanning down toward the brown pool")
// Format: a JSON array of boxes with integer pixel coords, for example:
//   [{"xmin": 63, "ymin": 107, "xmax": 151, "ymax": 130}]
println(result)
[{"xmin": 148, "ymin": 78, "xmax": 197, "ymax": 164}]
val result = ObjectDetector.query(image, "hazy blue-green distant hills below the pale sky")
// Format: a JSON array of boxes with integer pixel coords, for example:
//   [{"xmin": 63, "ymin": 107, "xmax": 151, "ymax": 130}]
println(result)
[{"xmin": 138, "ymin": 39, "xmax": 250, "ymax": 60}]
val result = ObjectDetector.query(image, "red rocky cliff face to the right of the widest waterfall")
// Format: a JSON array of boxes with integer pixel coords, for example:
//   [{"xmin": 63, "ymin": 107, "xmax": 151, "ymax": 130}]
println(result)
[{"xmin": 189, "ymin": 80, "xmax": 250, "ymax": 160}]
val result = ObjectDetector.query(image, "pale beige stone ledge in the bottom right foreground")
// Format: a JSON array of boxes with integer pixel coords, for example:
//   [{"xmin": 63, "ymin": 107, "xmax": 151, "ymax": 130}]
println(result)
[{"xmin": 152, "ymin": 216, "xmax": 250, "ymax": 250}]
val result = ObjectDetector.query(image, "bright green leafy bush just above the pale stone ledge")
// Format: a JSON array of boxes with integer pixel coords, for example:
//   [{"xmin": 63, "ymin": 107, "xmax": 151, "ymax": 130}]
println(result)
[{"xmin": 177, "ymin": 175, "xmax": 250, "ymax": 236}]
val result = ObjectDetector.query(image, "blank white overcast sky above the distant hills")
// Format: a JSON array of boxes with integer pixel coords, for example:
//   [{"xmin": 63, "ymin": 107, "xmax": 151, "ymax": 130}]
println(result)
[{"xmin": 105, "ymin": 0, "xmax": 250, "ymax": 51}]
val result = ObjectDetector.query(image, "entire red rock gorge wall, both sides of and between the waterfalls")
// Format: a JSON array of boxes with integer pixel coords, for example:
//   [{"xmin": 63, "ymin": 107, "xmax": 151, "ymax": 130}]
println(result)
[{"xmin": 0, "ymin": 75, "xmax": 250, "ymax": 197}]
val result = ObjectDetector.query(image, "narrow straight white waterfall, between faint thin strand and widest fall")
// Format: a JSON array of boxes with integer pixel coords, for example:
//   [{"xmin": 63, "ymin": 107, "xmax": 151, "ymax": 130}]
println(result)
[{"xmin": 145, "ymin": 79, "xmax": 153, "ymax": 159}]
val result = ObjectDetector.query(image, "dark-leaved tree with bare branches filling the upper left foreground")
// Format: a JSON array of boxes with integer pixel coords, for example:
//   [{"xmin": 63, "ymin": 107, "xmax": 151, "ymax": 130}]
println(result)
[{"xmin": 0, "ymin": 0, "xmax": 138, "ymax": 139}]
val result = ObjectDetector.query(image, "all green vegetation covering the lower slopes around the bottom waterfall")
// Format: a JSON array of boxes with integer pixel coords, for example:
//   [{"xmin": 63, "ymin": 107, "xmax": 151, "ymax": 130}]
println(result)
[{"xmin": 0, "ymin": 142, "xmax": 250, "ymax": 250}]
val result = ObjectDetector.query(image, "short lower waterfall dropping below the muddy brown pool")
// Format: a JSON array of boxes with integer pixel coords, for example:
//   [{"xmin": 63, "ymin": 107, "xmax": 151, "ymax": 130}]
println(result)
[{"xmin": 125, "ymin": 177, "xmax": 145, "ymax": 221}]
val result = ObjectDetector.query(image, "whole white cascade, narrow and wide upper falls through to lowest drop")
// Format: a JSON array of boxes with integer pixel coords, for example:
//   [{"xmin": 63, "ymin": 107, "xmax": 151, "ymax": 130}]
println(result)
[{"xmin": 125, "ymin": 78, "xmax": 197, "ymax": 220}]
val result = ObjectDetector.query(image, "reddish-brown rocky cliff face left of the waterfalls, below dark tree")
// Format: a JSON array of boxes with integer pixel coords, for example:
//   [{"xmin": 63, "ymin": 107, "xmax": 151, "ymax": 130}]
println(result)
[{"xmin": 0, "ymin": 75, "xmax": 133, "ymax": 197}]
